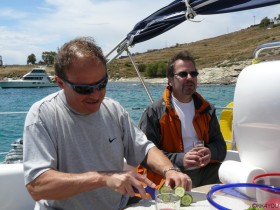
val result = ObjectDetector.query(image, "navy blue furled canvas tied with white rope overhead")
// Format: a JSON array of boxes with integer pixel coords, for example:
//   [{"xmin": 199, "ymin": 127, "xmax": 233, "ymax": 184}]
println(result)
[{"xmin": 126, "ymin": 0, "xmax": 280, "ymax": 46}]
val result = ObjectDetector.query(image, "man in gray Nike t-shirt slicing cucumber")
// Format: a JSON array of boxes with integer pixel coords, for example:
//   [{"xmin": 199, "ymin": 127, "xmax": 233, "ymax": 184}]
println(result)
[{"xmin": 23, "ymin": 38, "xmax": 191, "ymax": 210}]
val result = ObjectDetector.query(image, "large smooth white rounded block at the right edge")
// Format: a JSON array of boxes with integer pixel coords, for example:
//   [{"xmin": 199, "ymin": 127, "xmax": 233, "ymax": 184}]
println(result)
[{"xmin": 233, "ymin": 61, "xmax": 280, "ymax": 172}]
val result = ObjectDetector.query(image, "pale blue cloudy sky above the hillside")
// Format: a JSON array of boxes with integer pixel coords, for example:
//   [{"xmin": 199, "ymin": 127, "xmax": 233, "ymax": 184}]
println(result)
[{"xmin": 0, "ymin": 0, "xmax": 280, "ymax": 65}]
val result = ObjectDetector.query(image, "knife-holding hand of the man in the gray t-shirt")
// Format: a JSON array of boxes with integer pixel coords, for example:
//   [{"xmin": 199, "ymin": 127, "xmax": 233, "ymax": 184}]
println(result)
[{"xmin": 106, "ymin": 171, "xmax": 156, "ymax": 199}]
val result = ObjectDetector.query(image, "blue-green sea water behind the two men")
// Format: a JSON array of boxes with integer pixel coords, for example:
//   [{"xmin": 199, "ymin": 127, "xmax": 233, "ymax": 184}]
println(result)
[{"xmin": 0, "ymin": 82, "xmax": 235, "ymax": 163}]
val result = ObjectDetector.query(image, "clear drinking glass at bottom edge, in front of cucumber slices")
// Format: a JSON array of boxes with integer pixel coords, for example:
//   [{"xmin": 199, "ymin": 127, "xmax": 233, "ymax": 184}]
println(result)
[{"xmin": 156, "ymin": 193, "xmax": 181, "ymax": 210}]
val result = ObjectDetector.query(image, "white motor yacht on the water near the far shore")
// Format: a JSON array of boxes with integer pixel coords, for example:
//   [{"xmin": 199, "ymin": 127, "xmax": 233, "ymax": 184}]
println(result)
[{"xmin": 0, "ymin": 67, "xmax": 57, "ymax": 88}]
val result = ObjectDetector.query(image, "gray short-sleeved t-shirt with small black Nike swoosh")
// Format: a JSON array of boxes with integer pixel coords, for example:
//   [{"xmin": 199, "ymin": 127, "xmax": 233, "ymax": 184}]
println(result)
[{"xmin": 23, "ymin": 90, "xmax": 154, "ymax": 210}]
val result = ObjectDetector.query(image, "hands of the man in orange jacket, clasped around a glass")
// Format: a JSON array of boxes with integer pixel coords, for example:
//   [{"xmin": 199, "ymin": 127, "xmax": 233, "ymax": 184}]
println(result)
[{"xmin": 183, "ymin": 147, "xmax": 211, "ymax": 169}]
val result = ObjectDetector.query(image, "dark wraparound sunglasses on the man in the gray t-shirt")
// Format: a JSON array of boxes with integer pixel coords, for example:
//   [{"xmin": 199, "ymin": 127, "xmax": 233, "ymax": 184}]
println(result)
[{"xmin": 62, "ymin": 74, "xmax": 108, "ymax": 95}]
